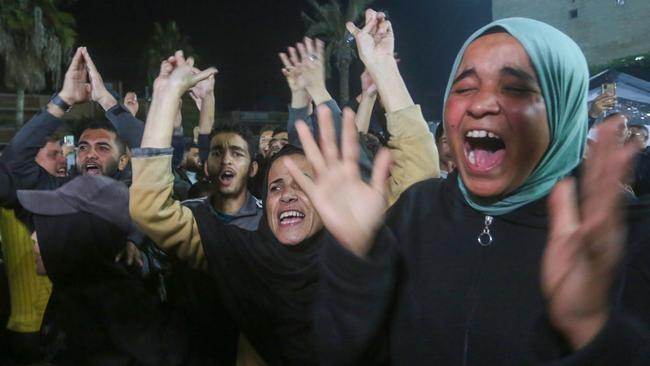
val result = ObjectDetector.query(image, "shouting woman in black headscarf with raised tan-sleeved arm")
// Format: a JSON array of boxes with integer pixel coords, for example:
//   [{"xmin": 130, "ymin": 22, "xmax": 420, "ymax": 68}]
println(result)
[{"xmin": 130, "ymin": 51, "xmax": 330, "ymax": 365}]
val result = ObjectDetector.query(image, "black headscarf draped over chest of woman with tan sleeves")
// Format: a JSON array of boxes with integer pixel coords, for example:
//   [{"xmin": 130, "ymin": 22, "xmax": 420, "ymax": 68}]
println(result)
[{"xmin": 193, "ymin": 145, "xmax": 324, "ymax": 364}]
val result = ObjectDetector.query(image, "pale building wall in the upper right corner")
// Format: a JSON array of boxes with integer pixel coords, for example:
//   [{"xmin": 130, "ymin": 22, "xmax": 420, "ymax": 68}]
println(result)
[{"xmin": 492, "ymin": 0, "xmax": 650, "ymax": 65}]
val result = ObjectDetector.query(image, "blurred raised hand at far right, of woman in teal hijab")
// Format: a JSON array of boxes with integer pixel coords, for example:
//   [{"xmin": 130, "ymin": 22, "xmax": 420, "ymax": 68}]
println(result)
[{"xmin": 542, "ymin": 124, "xmax": 636, "ymax": 349}]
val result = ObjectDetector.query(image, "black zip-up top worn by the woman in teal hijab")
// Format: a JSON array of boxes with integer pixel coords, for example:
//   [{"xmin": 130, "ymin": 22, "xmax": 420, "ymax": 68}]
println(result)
[{"xmin": 315, "ymin": 174, "xmax": 650, "ymax": 365}]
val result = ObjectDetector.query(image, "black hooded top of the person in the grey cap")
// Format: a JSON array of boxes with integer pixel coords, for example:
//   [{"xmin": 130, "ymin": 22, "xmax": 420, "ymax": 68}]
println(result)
[{"xmin": 34, "ymin": 213, "xmax": 188, "ymax": 366}]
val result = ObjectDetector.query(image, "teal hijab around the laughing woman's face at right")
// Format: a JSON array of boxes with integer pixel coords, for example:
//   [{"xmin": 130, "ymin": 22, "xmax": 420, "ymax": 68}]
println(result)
[{"xmin": 445, "ymin": 18, "xmax": 589, "ymax": 215}]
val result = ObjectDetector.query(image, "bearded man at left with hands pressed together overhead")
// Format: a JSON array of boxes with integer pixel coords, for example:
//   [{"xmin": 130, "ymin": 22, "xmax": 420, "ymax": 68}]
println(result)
[{"xmin": 3, "ymin": 47, "xmax": 143, "ymax": 189}]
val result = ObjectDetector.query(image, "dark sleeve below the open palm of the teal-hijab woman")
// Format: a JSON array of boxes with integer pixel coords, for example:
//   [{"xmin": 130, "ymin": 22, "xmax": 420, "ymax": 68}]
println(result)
[{"xmin": 314, "ymin": 228, "xmax": 398, "ymax": 365}]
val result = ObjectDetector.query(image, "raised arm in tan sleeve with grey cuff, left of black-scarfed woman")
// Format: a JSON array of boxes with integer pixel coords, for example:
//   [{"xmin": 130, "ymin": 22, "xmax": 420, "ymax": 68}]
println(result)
[{"xmin": 130, "ymin": 51, "xmax": 216, "ymax": 270}]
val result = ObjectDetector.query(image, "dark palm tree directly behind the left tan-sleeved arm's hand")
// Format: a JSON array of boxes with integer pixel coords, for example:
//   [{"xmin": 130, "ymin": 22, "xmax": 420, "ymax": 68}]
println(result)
[{"xmin": 144, "ymin": 21, "xmax": 196, "ymax": 85}]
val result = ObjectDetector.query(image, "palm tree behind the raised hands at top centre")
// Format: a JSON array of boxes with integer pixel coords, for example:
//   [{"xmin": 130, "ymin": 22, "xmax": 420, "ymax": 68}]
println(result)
[{"xmin": 302, "ymin": 0, "xmax": 374, "ymax": 103}]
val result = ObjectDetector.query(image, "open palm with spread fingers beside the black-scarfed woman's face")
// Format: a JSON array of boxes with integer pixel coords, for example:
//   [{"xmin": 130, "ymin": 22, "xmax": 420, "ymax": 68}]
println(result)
[{"xmin": 287, "ymin": 106, "xmax": 390, "ymax": 257}]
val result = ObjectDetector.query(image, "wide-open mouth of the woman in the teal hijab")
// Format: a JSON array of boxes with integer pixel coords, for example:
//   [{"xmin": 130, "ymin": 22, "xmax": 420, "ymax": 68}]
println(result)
[{"xmin": 465, "ymin": 130, "xmax": 506, "ymax": 172}]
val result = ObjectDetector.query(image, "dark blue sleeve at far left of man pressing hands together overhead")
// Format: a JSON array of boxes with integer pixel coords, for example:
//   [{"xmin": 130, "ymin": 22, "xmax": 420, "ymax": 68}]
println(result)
[{"xmin": 3, "ymin": 110, "xmax": 65, "ymax": 189}]
